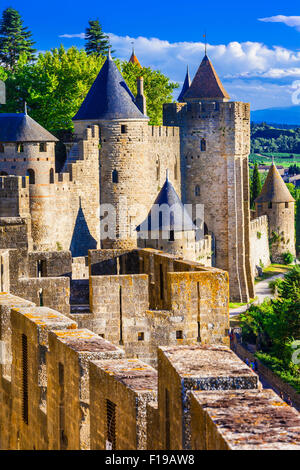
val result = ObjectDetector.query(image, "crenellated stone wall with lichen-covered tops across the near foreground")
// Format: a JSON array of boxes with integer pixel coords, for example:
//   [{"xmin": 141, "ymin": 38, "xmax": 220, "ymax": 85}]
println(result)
[{"xmin": 0, "ymin": 294, "xmax": 300, "ymax": 450}]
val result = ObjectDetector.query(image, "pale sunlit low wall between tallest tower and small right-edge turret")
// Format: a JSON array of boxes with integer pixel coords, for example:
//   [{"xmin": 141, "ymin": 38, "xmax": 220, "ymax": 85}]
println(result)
[{"xmin": 250, "ymin": 216, "xmax": 271, "ymax": 276}]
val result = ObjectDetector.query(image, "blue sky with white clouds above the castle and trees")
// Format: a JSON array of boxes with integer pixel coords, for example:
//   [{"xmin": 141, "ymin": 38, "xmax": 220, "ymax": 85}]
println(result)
[{"xmin": 4, "ymin": 0, "xmax": 300, "ymax": 109}]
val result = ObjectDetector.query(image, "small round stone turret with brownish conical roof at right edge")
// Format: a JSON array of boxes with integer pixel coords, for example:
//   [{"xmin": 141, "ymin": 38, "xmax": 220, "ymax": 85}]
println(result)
[{"xmin": 255, "ymin": 163, "xmax": 296, "ymax": 263}]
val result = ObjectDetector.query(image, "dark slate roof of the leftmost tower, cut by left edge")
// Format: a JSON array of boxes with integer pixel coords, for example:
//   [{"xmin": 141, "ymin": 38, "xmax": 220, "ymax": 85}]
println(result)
[{"xmin": 0, "ymin": 113, "xmax": 58, "ymax": 142}]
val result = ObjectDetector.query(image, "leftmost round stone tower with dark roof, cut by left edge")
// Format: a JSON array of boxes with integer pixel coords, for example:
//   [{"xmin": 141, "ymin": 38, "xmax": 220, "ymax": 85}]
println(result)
[{"xmin": 0, "ymin": 111, "xmax": 57, "ymax": 250}]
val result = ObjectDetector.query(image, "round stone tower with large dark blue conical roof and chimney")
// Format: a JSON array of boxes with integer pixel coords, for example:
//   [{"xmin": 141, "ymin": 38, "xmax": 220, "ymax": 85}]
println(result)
[{"xmin": 74, "ymin": 50, "xmax": 154, "ymax": 248}]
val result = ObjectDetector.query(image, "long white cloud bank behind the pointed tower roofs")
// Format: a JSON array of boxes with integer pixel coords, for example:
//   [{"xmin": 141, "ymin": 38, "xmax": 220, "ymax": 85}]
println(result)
[{"xmin": 56, "ymin": 33, "xmax": 300, "ymax": 109}]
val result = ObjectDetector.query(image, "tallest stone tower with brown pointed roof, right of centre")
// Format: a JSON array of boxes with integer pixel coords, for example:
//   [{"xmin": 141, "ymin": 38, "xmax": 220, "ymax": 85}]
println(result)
[{"xmin": 164, "ymin": 55, "xmax": 254, "ymax": 302}]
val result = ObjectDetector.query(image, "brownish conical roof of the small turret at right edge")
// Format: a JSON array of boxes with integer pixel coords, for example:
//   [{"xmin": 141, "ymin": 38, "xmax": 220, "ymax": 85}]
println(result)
[{"xmin": 255, "ymin": 163, "xmax": 295, "ymax": 203}]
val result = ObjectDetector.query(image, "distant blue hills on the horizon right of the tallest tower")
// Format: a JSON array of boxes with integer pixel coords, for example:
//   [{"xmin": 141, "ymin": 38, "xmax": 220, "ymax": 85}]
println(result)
[{"xmin": 251, "ymin": 106, "xmax": 300, "ymax": 126}]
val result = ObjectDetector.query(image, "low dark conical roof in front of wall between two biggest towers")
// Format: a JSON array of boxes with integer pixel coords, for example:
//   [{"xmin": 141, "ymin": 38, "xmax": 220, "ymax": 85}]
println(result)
[{"xmin": 136, "ymin": 177, "xmax": 197, "ymax": 232}]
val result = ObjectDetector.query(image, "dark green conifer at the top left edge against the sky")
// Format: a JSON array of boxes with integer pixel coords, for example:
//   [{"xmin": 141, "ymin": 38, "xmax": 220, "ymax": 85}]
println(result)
[{"xmin": 0, "ymin": 8, "xmax": 36, "ymax": 70}]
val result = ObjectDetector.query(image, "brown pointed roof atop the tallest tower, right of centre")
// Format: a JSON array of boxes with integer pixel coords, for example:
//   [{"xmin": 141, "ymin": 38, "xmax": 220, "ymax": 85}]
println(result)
[{"xmin": 184, "ymin": 54, "xmax": 230, "ymax": 101}]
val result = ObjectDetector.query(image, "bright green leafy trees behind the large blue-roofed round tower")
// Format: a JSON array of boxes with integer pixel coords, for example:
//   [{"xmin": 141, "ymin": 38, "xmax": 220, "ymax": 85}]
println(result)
[{"xmin": 0, "ymin": 46, "xmax": 177, "ymax": 131}]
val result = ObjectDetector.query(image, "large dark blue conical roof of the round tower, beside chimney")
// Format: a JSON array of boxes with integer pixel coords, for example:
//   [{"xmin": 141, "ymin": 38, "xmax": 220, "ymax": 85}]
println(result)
[{"xmin": 73, "ymin": 53, "xmax": 147, "ymax": 121}]
